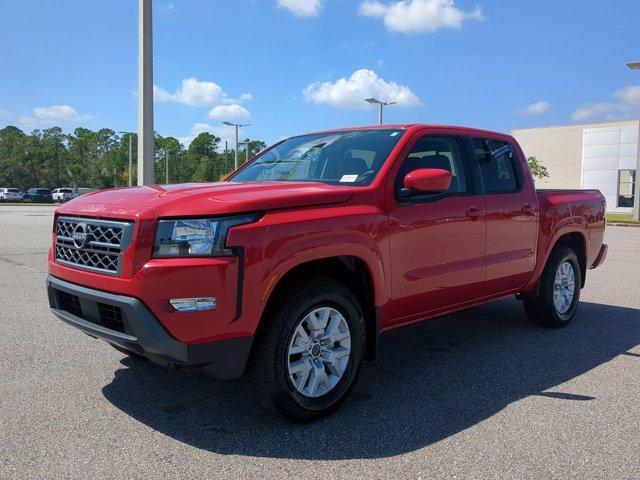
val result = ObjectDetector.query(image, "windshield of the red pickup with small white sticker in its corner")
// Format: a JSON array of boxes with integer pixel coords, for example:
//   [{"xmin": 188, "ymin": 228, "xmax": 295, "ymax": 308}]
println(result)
[{"xmin": 230, "ymin": 129, "xmax": 404, "ymax": 185}]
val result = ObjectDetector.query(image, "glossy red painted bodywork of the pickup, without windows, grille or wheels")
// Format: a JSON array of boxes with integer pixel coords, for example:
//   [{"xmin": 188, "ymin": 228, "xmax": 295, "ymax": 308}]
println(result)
[{"xmin": 49, "ymin": 125, "xmax": 606, "ymax": 343}]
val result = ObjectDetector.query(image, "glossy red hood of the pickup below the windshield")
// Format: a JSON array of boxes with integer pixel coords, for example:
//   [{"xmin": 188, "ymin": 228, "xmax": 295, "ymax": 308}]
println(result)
[{"xmin": 58, "ymin": 182, "xmax": 353, "ymax": 217}]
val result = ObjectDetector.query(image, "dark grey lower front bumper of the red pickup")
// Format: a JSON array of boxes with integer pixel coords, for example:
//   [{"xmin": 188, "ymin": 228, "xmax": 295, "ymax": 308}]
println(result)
[{"xmin": 47, "ymin": 275, "xmax": 253, "ymax": 380}]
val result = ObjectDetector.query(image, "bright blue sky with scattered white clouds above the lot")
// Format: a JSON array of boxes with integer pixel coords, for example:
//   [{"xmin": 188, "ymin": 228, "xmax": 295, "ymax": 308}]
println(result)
[{"xmin": 0, "ymin": 0, "xmax": 640, "ymax": 146}]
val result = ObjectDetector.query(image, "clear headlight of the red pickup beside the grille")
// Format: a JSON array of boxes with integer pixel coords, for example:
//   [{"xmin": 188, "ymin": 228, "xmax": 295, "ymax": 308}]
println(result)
[{"xmin": 153, "ymin": 214, "xmax": 258, "ymax": 258}]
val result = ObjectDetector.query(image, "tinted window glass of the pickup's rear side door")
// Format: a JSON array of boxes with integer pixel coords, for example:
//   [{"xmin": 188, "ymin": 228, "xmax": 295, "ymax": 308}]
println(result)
[{"xmin": 473, "ymin": 138, "xmax": 521, "ymax": 193}]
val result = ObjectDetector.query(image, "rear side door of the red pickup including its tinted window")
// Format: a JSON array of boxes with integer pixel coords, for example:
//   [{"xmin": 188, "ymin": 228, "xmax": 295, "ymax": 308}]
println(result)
[{"xmin": 470, "ymin": 137, "xmax": 538, "ymax": 294}]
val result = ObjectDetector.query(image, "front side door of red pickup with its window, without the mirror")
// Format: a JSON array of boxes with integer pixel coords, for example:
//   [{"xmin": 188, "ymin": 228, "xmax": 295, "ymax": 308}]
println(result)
[{"xmin": 387, "ymin": 134, "xmax": 486, "ymax": 324}]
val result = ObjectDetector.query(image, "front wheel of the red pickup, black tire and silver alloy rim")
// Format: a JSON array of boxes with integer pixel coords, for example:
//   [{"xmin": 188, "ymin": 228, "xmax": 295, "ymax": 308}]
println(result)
[{"xmin": 243, "ymin": 279, "xmax": 365, "ymax": 423}]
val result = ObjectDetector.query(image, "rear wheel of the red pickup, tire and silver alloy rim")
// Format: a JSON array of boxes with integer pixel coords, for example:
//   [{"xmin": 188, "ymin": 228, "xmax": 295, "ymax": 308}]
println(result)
[{"xmin": 524, "ymin": 247, "xmax": 582, "ymax": 328}]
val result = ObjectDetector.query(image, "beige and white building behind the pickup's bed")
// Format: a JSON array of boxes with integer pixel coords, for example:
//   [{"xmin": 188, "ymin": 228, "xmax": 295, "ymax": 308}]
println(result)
[{"xmin": 512, "ymin": 120, "xmax": 640, "ymax": 212}]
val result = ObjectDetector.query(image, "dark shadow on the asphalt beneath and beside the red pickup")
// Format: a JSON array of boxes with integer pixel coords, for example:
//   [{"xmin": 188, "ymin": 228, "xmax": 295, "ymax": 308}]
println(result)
[{"xmin": 103, "ymin": 299, "xmax": 640, "ymax": 460}]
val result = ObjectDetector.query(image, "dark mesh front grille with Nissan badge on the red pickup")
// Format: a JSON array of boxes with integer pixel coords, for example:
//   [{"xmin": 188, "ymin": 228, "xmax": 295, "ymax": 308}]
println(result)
[{"xmin": 55, "ymin": 217, "xmax": 134, "ymax": 275}]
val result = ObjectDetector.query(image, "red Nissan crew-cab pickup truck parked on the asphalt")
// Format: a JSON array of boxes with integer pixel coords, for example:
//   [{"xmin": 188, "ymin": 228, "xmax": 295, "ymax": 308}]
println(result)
[{"xmin": 47, "ymin": 125, "xmax": 607, "ymax": 421}]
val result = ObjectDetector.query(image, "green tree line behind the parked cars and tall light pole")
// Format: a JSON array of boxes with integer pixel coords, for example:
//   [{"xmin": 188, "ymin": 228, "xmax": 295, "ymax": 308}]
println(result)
[{"xmin": 0, "ymin": 126, "xmax": 266, "ymax": 191}]
